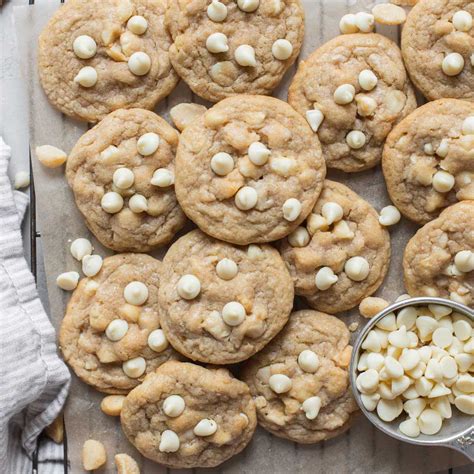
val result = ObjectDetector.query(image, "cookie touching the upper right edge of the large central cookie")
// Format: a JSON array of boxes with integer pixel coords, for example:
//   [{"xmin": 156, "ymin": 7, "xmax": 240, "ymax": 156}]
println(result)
[{"xmin": 288, "ymin": 33, "xmax": 416, "ymax": 172}]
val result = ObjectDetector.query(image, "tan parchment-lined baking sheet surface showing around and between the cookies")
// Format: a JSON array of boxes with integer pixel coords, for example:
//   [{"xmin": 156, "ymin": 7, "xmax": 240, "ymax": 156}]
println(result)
[{"xmin": 15, "ymin": 0, "xmax": 466, "ymax": 474}]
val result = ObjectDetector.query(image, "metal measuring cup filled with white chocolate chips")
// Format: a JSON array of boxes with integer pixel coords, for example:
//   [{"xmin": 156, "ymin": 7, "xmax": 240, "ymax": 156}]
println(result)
[{"xmin": 350, "ymin": 298, "xmax": 474, "ymax": 460}]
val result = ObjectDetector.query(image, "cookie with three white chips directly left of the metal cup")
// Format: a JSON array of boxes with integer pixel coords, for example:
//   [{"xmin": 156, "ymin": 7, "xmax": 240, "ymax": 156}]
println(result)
[{"xmin": 242, "ymin": 310, "xmax": 357, "ymax": 443}]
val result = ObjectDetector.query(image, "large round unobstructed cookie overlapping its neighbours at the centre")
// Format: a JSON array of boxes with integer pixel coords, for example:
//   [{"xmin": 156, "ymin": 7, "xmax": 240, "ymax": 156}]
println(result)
[{"xmin": 175, "ymin": 95, "xmax": 326, "ymax": 245}]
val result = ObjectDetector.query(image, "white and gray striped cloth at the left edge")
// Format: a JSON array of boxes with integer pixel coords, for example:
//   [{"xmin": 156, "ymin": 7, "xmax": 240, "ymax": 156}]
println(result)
[{"xmin": 0, "ymin": 137, "xmax": 70, "ymax": 474}]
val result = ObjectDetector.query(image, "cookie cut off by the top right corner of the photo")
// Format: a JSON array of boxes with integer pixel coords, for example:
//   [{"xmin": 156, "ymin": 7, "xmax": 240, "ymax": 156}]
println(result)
[{"xmin": 401, "ymin": 0, "xmax": 474, "ymax": 101}]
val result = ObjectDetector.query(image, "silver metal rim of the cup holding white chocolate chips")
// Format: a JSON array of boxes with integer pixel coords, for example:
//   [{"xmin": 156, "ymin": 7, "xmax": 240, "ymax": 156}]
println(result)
[{"xmin": 349, "ymin": 296, "xmax": 474, "ymax": 446}]
